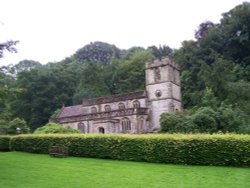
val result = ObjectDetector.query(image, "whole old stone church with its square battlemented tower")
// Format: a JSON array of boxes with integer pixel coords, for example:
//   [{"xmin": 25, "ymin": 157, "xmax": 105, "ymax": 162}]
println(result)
[{"xmin": 53, "ymin": 58, "xmax": 182, "ymax": 134}]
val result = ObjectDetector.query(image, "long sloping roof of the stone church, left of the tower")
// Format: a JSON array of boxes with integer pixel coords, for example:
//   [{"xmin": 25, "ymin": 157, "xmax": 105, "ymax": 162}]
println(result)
[{"xmin": 56, "ymin": 91, "xmax": 146, "ymax": 118}]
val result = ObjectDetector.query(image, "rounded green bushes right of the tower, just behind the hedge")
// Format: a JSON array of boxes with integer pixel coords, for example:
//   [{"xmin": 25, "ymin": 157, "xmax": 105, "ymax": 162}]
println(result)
[{"xmin": 160, "ymin": 88, "xmax": 250, "ymax": 134}]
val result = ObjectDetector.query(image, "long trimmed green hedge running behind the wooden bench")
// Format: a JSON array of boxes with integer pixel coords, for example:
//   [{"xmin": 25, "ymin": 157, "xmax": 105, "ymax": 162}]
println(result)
[{"xmin": 7, "ymin": 134, "xmax": 250, "ymax": 166}]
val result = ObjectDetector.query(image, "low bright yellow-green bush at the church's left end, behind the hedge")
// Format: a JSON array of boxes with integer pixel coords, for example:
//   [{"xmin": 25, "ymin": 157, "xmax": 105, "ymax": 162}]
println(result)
[{"xmin": 34, "ymin": 123, "xmax": 79, "ymax": 134}]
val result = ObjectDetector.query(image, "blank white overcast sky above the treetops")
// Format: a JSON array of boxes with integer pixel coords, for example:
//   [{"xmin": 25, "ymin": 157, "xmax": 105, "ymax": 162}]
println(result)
[{"xmin": 0, "ymin": 0, "xmax": 246, "ymax": 66}]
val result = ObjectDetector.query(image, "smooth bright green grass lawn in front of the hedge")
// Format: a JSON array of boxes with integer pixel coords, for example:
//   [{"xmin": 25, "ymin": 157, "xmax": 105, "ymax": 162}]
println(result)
[{"xmin": 0, "ymin": 152, "xmax": 250, "ymax": 188}]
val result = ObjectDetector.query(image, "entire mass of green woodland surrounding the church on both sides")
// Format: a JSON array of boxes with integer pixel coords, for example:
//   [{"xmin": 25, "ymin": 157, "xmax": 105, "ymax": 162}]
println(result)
[{"xmin": 0, "ymin": 2, "xmax": 250, "ymax": 134}]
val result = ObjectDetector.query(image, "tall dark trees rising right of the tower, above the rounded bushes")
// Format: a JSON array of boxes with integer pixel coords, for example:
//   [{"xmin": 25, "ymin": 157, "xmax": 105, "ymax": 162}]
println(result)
[{"xmin": 174, "ymin": 2, "xmax": 250, "ymax": 112}]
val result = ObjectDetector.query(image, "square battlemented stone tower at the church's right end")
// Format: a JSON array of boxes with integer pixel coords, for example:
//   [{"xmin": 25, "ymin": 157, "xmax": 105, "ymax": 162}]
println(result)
[{"xmin": 146, "ymin": 58, "xmax": 182, "ymax": 130}]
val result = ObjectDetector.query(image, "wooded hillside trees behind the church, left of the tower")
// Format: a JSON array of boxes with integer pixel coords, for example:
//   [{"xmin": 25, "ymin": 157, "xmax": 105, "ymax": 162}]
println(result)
[{"xmin": 0, "ymin": 43, "xmax": 157, "ymax": 130}]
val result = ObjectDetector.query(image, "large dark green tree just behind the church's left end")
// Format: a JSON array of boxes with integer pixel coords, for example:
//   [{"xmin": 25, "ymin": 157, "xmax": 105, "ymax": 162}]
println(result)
[{"xmin": 11, "ymin": 64, "xmax": 77, "ymax": 130}]
